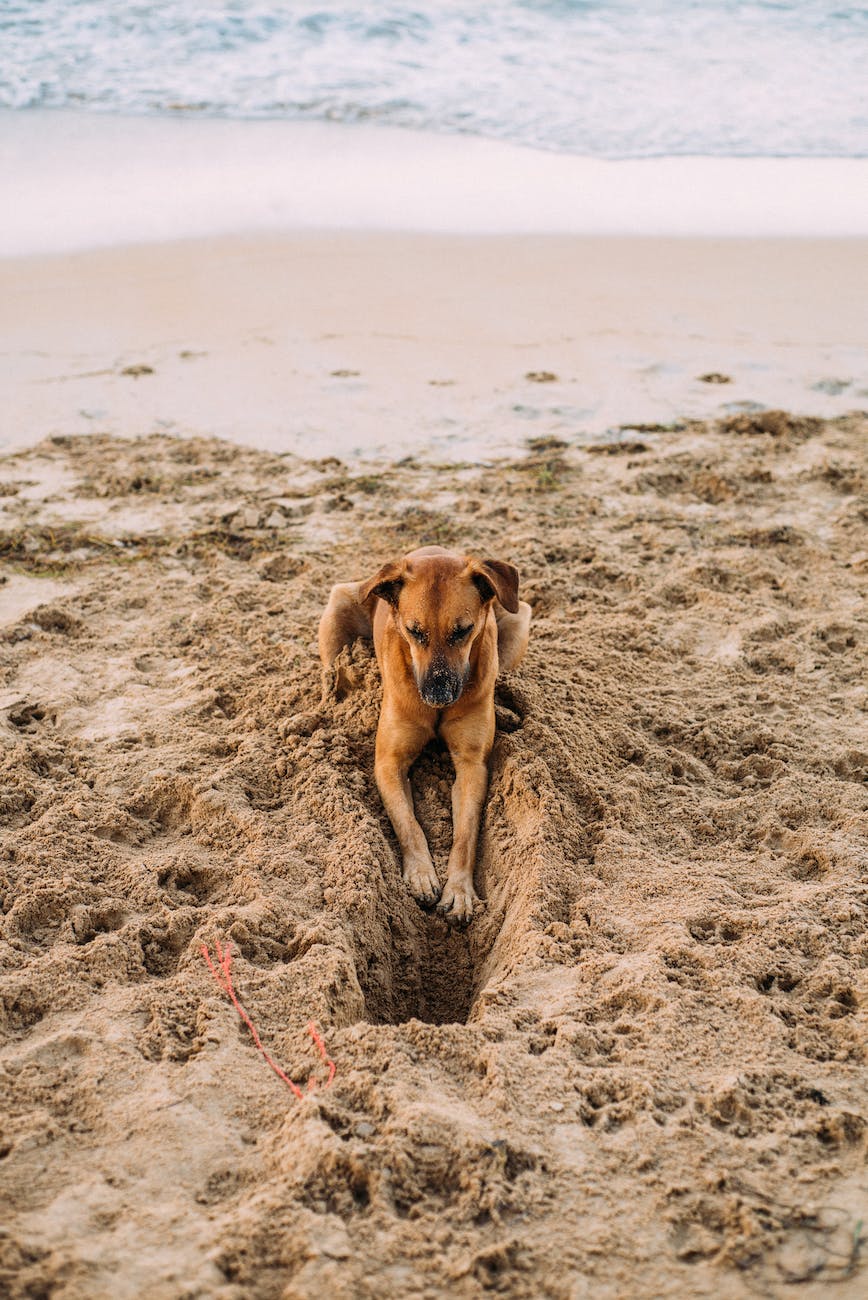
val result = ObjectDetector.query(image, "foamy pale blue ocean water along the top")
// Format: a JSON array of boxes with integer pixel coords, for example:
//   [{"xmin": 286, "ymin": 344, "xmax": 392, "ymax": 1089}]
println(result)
[{"xmin": 0, "ymin": 0, "xmax": 868, "ymax": 159}]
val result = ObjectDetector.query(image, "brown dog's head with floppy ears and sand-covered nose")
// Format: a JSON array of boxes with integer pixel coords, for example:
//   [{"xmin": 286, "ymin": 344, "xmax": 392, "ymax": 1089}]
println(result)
[{"xmin": 360, "ymin": 551, "xmax": 518, "ymax": 709}]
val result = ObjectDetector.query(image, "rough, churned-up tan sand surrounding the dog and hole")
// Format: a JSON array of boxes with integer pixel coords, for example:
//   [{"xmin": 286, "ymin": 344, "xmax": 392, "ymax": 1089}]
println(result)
[{"xmin": 0, "ymin": 403, "xmax": 868, "ymax": 1300}]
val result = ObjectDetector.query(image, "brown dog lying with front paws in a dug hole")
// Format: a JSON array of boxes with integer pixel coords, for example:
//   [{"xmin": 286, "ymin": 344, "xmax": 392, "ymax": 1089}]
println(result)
[{"xmin": 320, "ymin": 546, "xmax": 530, "ymax": 922}]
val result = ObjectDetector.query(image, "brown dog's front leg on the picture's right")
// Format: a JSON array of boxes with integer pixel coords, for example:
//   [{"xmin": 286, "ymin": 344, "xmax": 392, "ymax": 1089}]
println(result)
[{"xmin": 437, "ymin": 706, "xmax": 494, "ymax": 922}]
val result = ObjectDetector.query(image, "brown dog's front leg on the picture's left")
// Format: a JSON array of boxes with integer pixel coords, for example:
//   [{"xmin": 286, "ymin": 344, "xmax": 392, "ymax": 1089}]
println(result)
[{"xmin": 374, "ymin": 710, "xmax": 440, "ymax": 907}]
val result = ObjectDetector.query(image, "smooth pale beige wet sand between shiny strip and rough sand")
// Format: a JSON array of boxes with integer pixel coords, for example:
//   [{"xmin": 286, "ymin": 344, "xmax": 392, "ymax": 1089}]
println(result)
[{"xmin": 0, "ymin": 230, "xmax": 868, "ymax": 460}]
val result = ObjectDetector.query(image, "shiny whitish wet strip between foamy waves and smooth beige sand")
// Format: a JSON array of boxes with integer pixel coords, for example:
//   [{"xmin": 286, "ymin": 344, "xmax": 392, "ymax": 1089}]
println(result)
[{"xmin": 0, "ymin": 109, "xmax": 868, "ymax": 256}]
